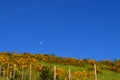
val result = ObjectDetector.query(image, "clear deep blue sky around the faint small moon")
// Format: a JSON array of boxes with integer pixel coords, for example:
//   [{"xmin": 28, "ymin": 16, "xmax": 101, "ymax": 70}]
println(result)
[{"xmin": 0, "ymin": 0, "xmax": 120, "ymax": 60}]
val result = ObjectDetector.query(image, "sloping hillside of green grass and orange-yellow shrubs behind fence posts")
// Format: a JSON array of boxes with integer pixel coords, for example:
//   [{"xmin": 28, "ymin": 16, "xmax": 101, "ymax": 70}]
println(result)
[{"xmin": 0, "ymin": 52, "xmax": 120, "ymax": 80}]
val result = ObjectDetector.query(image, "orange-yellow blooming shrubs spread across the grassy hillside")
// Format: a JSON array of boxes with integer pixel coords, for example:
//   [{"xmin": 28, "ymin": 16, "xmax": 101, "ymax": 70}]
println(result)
[{"xmin": 0, "ymin": 52, "xmax": 120, "ymax": 80}]
